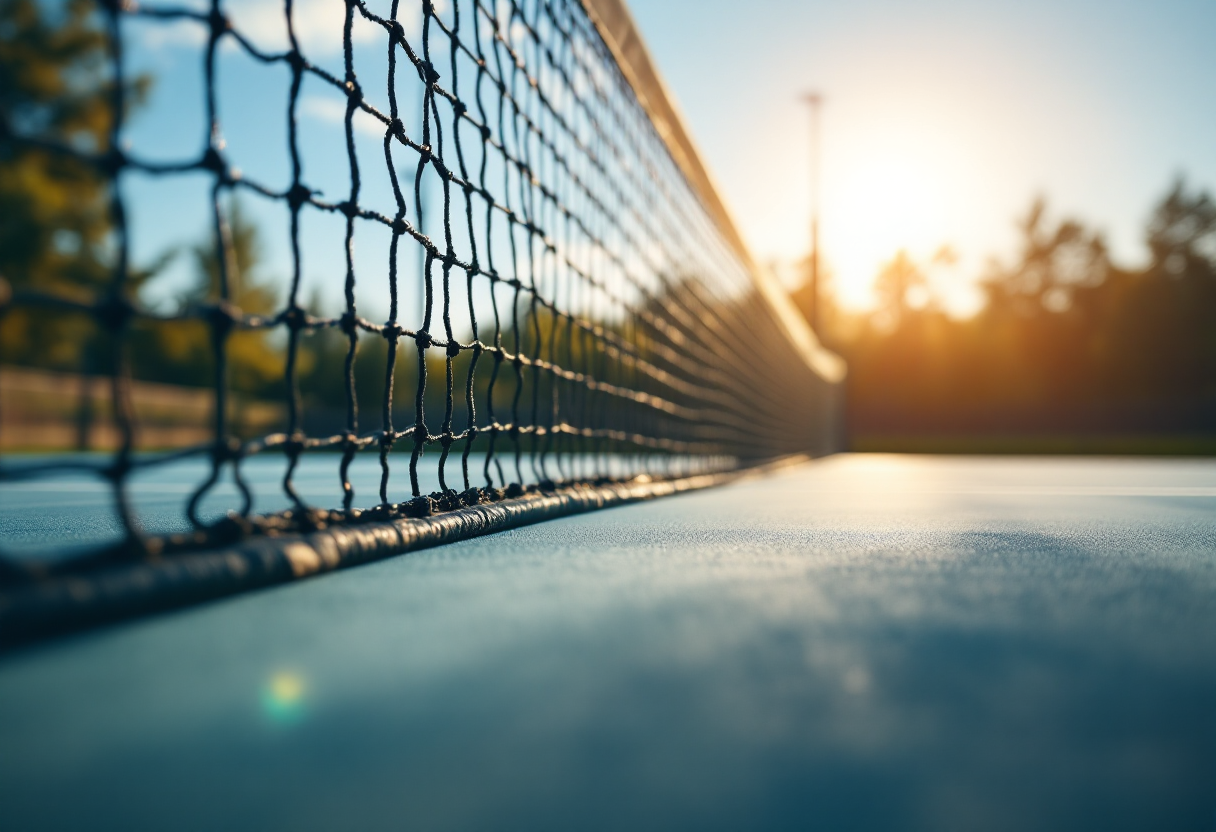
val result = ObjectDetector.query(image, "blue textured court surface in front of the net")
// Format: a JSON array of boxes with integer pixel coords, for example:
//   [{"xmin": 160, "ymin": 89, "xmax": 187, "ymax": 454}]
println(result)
[{"xmin": 0, "ymin": 456, "xmax": 1216, "ymax": 830}]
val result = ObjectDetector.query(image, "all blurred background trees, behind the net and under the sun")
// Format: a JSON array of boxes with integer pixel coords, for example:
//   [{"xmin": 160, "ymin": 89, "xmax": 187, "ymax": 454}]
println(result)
[{"xmin": 0, "ymin": 0, "xmax": 1216, "ymax": 450}]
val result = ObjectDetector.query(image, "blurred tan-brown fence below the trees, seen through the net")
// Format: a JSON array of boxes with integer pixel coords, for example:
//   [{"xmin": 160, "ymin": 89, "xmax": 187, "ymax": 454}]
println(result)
[{"xmin": 0, "ymin": 366, "xmax": 286, "ymax": 450}]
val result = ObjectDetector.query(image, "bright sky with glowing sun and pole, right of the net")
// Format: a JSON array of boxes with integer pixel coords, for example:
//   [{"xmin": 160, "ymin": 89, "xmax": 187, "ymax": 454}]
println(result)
[{"xmin": 631, "ymin": 0, "xmax": 1216, "ymax": 313}]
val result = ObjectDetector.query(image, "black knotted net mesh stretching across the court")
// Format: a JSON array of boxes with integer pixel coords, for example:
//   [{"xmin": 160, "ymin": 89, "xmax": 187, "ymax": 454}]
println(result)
[{"xmin": 0, "ymin": 0, "xmax": 826, "ymax": 574}]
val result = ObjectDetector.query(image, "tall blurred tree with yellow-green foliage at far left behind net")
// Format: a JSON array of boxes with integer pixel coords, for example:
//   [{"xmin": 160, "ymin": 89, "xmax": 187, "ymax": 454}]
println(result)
[{"xmin": 0, "ymin": 0, "xmax": 150, "ymax": 369}]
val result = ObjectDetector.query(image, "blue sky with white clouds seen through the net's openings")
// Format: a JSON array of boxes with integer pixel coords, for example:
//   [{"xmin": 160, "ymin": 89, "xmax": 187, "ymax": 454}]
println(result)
[{"xmin": 123, "ymin": 0, "xmax": 442, "ymax": 322}]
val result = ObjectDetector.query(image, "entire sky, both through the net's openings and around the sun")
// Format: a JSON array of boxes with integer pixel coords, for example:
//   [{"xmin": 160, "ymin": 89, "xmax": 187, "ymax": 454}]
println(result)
[{"xmin": 116, "ymin": 0, "xmax": 1216, "ymax": 314}]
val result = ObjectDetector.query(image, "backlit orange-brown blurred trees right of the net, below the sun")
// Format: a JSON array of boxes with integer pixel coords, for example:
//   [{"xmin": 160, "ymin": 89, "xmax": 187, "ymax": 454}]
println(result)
[{"xmin": 795, "ymin": 180, "xmax": 1216, "ymax": 450}]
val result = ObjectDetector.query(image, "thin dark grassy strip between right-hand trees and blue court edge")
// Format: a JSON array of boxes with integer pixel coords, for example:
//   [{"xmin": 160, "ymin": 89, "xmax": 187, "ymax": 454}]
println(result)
[{"xmin": 849, "ymin": 433, "xmax": 1216, "ymax": 456}]
